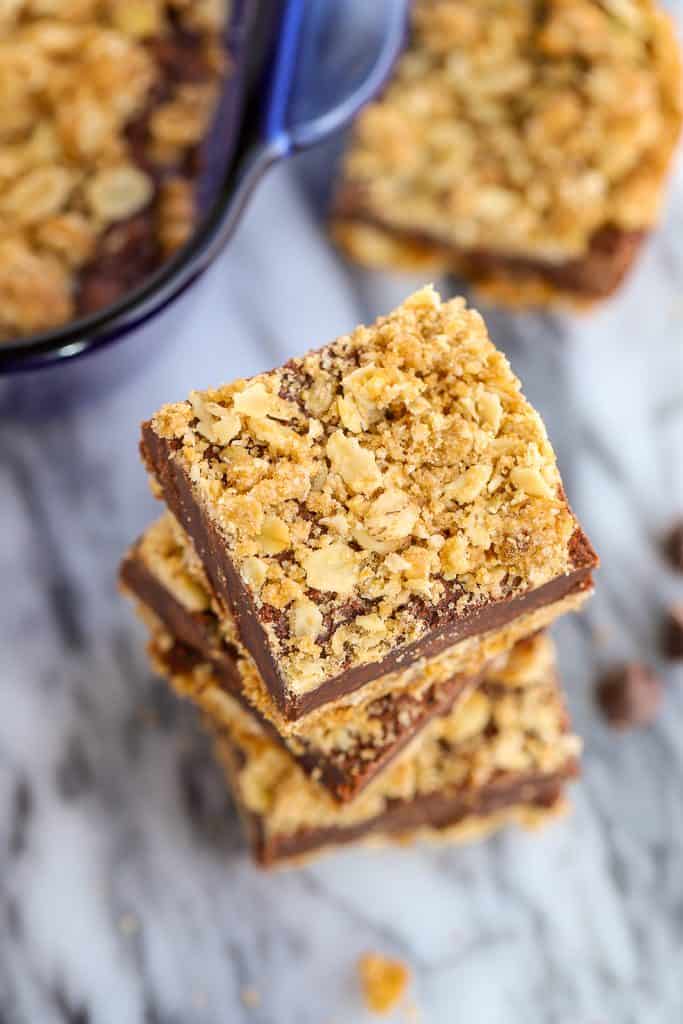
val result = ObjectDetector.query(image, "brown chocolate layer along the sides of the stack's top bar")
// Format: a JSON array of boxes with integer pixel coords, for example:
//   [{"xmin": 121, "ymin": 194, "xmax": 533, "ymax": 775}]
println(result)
[{"xmin": 140, "ymin": 422, "xmax": 598, "ymax": 721}]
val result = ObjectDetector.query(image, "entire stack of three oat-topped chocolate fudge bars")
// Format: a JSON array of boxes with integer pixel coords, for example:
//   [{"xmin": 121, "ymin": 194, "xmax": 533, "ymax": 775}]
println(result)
[{"xmin": 121, "ymin": 288, "xmax": 597, "ymax": 865}]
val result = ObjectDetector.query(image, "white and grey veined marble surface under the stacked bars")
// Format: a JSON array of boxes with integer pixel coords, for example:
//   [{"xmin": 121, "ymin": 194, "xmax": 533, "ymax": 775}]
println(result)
[{"xmin": 0, "ymin": 96, "xmax": 683, "ymax": 1024}]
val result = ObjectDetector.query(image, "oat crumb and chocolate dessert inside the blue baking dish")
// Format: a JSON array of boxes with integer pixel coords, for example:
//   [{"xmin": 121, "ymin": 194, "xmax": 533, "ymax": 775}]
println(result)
[{"xmin": 0, "ymin": 0, "xmax": 227, "ymax": 341}]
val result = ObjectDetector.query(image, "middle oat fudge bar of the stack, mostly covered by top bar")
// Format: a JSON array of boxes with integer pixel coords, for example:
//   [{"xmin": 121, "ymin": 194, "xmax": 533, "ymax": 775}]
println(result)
[{"xmin": 121, "ymin": 513, "xmax": 586, "ymax": 801}]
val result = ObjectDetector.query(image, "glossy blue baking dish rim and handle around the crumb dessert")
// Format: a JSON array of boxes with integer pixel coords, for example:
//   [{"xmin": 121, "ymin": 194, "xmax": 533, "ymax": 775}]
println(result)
[{"xmin": 0, "ymin": 0, "xmax": 410, "ymax": 374}]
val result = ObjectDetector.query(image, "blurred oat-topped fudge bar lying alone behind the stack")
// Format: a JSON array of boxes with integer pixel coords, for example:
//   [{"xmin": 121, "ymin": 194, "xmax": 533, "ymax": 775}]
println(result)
[{"xmin": 333, "ymin": 0, "xmax": 682, "ymax": 306}]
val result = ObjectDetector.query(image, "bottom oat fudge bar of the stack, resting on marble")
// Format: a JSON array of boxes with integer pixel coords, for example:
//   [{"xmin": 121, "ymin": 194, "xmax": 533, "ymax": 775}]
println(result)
[{"xmin": 200, "ymin": 635, "xmax": 581, "ymax": 865}]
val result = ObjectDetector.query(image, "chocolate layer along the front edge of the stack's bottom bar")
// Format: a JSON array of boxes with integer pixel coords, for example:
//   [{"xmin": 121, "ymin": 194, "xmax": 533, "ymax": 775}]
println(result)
[{"xmin": 233, "ymin": 765, "xmax": 579, "ymax": 867}]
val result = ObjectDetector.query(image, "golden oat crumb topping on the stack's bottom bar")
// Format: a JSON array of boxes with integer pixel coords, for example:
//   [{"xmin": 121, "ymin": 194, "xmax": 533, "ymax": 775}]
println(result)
[{"xmin": 185, "ymin": 641, "xmax": 581, "ymax": 835}]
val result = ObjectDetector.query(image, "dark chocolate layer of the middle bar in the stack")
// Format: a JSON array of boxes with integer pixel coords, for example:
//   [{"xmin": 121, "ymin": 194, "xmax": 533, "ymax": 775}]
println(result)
[{"xmin": 121, "ymin": 553, "xmax": 481, "ymax": 802}]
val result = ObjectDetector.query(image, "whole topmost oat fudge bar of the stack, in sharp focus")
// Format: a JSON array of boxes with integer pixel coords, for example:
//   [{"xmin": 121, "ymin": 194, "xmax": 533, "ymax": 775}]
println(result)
[{"xmin": 142, "ymin": 288, "xmax": 597, "ymax": 718}]
